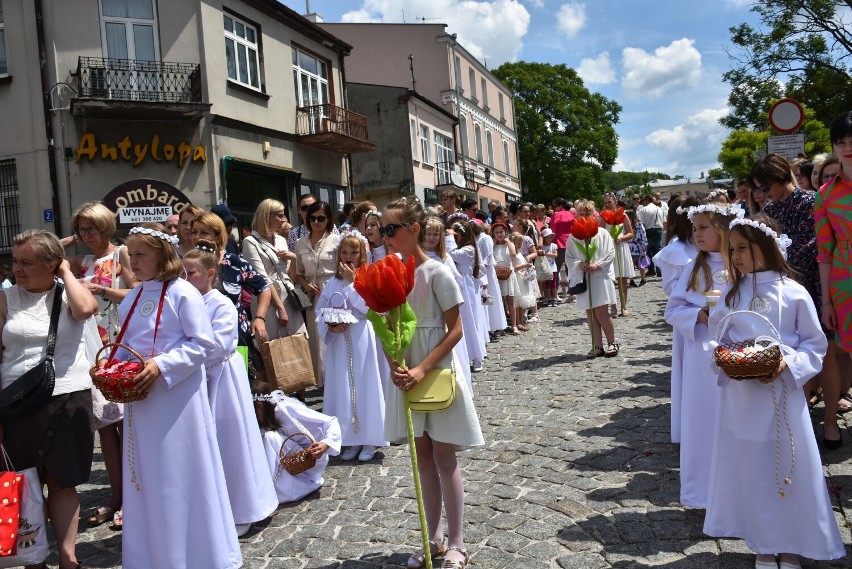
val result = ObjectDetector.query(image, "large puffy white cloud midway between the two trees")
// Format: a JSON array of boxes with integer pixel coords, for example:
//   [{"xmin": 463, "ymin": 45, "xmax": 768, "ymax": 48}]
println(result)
[{"xmin": 621, "ymin": 38, "xmax": 701, "ymax": 99}]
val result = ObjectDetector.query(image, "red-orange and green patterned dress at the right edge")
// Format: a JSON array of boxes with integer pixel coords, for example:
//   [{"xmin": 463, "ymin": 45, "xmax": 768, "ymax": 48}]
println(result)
[{"xmin": 814, "ymin": 175, "xmax": 852, "ymax": 352}]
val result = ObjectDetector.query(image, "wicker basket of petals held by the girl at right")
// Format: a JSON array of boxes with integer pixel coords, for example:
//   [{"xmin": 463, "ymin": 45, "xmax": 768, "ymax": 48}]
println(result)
[{"xmin": 713, "ymin": 310, "xmax": 782, "ymax": 380}]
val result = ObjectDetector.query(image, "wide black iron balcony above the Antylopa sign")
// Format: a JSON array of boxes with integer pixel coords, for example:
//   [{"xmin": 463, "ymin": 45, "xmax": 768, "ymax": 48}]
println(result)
[{"xmin": 71, "ymin": 57, "xmax": 210, "ymax": 121}]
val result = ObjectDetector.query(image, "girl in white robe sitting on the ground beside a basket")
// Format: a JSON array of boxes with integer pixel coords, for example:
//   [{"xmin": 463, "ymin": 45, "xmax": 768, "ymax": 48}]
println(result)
[{"xmin": 251, "ymin": 380, "xmax": 341, "ymax": 504}]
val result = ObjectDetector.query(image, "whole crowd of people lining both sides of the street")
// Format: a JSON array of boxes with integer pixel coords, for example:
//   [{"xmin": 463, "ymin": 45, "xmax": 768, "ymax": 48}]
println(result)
[{"xmin": 0, "ymin": 113, "xmax": 852, "ymax": 569}]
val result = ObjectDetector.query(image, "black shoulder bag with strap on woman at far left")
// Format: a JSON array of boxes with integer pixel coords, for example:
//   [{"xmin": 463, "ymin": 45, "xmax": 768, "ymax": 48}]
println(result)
[{"xmin": 0, "ymin": 281, "xmax": 65, "ymax": 415}]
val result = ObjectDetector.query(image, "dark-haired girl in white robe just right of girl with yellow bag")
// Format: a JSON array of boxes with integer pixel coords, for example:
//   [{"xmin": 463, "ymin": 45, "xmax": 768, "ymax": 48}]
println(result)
[{"xmin": 447, "ymin": 221, "xmax": 486, "ymax": 372}]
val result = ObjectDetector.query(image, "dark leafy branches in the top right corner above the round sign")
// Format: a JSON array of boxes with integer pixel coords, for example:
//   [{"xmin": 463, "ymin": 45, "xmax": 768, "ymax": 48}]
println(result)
[{"xmin": 720, "ymin": 0, "xmax": 852, "ymax": 129}]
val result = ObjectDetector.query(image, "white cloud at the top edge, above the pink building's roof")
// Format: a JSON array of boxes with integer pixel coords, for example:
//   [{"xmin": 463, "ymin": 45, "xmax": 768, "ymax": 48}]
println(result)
[{"xmin": 341, "ymin": 0, "xmax": 537, "ymax": 64}]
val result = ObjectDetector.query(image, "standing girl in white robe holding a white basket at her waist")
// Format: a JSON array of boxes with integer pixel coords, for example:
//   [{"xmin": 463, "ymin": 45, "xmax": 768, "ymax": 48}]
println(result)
[{"xmin": 316, "ymin": 231, "xmax": 390, "ymax": 462}]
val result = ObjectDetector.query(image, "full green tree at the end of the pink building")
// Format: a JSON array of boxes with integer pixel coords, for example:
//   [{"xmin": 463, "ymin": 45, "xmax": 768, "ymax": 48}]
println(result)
[{"xmin": 494, "ymin": 61, "xmax": 621, "ymax": 203}]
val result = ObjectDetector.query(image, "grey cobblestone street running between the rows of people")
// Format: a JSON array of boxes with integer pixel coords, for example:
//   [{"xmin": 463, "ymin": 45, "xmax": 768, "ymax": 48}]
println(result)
[{"xmin": 71, "ymin": 279, "xmax": 852, "ymax": 569}]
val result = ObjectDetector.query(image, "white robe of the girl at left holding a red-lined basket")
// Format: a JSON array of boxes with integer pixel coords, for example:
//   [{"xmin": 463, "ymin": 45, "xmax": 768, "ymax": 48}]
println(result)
[{"xmin": 118, "ymin": 279, "xmax": 243, "ymax": 569}]
